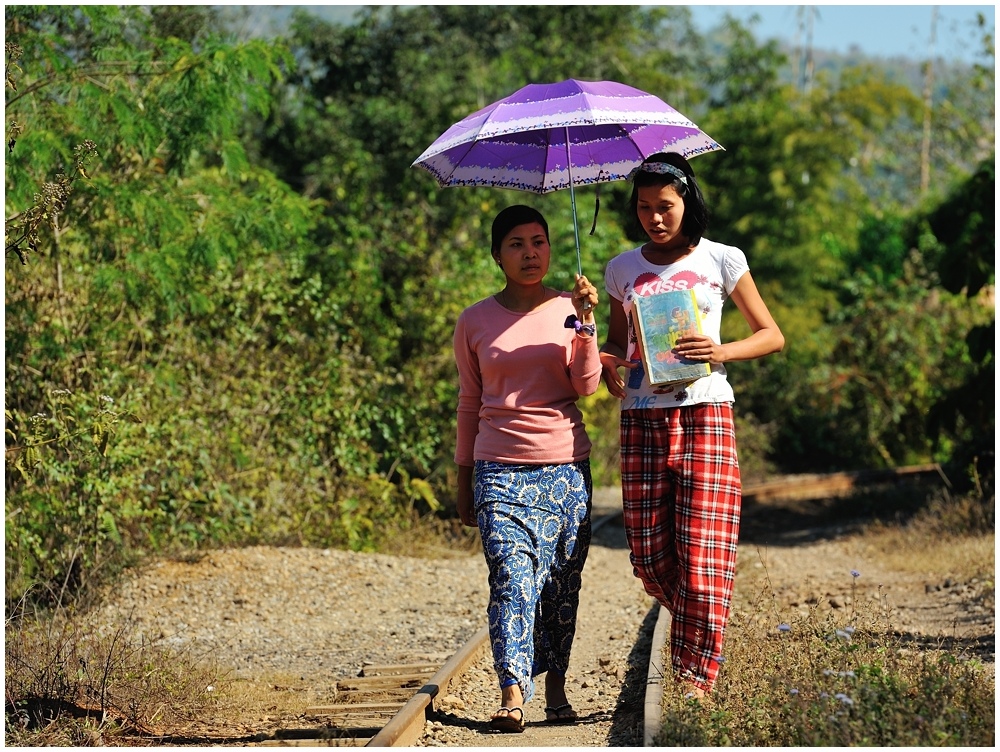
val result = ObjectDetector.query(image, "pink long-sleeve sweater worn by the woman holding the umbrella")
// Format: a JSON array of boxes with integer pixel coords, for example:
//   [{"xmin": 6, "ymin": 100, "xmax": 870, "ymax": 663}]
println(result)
[{"xmin": 454, "ymin": 292, "xmax": 601, "ymax": 466}]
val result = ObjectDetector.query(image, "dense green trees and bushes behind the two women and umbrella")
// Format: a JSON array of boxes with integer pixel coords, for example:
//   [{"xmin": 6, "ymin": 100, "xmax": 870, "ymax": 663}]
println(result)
[{"xmin": 5, "ymin": 6, "xmax": 995, "ymax": 594}]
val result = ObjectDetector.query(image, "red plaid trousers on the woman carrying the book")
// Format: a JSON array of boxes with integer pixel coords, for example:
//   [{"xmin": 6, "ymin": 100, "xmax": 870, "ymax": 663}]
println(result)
[{"xmin": 621, "ymin": 403, "xmax": 742, "ymax": 690}]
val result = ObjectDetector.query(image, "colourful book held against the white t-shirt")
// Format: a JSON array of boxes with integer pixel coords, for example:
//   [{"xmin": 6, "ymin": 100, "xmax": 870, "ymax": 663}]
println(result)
[{"xmin": 632, "ymin": 290, "xmax": 712, "ymax": 386}]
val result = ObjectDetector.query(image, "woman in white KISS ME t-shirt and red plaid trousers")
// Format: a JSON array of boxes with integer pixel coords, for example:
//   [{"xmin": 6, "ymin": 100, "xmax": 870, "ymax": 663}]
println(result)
[{"xmin": 601, "ymin": 153, "xmax": 785, "ymax": 698}]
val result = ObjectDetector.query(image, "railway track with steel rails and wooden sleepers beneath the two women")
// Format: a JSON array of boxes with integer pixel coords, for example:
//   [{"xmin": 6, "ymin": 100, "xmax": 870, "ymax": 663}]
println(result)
[{"xmin": 258, "ymin": 465, "xmax": 947, "ymax": 747}]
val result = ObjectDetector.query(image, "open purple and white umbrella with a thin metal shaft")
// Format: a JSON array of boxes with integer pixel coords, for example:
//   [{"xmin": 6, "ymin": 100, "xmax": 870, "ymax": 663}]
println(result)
[{"xmin": 411, "ymin": 78, "xmax": 722, "ymax": 274}]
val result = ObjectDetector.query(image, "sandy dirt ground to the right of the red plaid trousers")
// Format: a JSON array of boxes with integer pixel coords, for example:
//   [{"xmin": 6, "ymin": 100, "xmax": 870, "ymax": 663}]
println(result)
[{"xmin": 737, "ymin": 500, "xmax": 996, "ymax": 665}]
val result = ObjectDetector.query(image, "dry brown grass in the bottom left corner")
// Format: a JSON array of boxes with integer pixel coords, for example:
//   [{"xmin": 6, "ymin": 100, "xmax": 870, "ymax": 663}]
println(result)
[{"xmin": 5, "ymin": 612, "xmax": 332, "ymax": 747}]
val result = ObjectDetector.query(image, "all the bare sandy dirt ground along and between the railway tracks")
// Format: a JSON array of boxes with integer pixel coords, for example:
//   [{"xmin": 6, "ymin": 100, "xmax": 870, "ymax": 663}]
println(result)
[{"xmin": 99, "ymin": 490, "xmax": 995, "ymax": 747}]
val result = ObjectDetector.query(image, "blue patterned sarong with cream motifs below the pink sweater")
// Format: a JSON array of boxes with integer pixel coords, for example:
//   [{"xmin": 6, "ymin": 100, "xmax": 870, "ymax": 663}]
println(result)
[{"xmin": 474, "ymin": 460, "xmax": 593, "ymax": 702}]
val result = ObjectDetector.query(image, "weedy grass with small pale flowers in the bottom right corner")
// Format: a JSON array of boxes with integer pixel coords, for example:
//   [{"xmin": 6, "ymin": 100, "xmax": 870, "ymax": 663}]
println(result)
[{"xmin": 656, "ymin": 609, "xmax": 995, "ymax": 747}]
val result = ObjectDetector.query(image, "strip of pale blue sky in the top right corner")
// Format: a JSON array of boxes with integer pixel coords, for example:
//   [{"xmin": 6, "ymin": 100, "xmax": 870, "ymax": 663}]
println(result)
[{"xmin": 691, "ymin": 3, "xmax": 996, "ymax": 62}]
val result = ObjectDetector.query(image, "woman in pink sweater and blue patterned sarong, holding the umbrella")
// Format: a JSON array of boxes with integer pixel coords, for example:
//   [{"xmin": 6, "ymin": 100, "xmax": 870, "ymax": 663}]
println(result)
[{"xmin": 454, "ymin": 206, "xmax": 601, "ymax": 732}]
